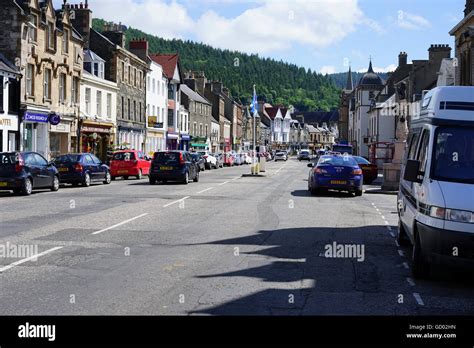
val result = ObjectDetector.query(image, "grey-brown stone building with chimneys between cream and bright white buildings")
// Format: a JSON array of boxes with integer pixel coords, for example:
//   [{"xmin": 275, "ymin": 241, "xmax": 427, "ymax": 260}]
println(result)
[{"xmin": 65, "ymin": 1, "xmax": 149, "ymax": 151}]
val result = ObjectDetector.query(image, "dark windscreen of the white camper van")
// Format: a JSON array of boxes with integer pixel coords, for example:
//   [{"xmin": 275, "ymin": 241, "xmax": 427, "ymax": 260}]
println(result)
[{"xmin": 432, "ymin": 127, "xmax": 474, "ymax": 183}]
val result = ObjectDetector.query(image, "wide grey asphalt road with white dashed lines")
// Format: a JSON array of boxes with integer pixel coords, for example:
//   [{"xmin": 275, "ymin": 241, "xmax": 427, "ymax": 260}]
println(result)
[{"xmin": 0, "ymin": 159, "xmax": 474, "ymax": 315}]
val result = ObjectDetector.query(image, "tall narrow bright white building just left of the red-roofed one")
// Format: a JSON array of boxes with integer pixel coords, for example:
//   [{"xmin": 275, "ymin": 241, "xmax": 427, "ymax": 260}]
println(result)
[{"xmin": 145, "ymin": 60, "xmax": 168, "ymax": 156}]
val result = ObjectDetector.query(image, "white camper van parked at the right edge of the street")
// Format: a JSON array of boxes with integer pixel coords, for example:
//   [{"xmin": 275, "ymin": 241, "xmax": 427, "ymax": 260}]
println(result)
[{"xmin": 398, "ymin": 87, "xmax": 474, "ymax": 278}]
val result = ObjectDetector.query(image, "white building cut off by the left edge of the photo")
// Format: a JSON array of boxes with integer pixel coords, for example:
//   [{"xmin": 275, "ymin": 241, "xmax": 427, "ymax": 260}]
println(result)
[{"xmin": 0, "ymin": 54, "xmax": 20, "ymax": 152}]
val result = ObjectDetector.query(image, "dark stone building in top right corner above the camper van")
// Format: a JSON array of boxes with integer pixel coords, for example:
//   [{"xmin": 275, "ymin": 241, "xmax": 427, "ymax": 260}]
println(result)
[{"xmin": 449, "ymin": 0, "xmax": 474, "ymax": 86}]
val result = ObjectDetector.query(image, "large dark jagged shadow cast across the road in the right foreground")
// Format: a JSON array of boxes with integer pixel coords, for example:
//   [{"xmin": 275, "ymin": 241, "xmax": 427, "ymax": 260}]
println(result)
[{"xmin": 189, "ymin": 225, "xmax": 474, "ymax": 315}]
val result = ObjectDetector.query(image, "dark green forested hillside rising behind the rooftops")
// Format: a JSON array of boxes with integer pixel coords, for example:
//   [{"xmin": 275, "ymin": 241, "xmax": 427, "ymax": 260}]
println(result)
[{"xmin": 93, "ymin": 19, "xmax": 339, "ymax": 111}]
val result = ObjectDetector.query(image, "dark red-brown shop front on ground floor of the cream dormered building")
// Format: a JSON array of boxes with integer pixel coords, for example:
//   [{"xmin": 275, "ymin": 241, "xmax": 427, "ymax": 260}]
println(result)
[{"xmin": 79, "ymin": 121, "xmax": 114, "ymax": 162}]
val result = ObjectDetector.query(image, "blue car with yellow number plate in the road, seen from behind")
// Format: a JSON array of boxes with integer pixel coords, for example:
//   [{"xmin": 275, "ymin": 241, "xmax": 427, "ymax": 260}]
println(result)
[{"xmin": 308, "ymin": 155, "xmax": 364, "ymax": 196}]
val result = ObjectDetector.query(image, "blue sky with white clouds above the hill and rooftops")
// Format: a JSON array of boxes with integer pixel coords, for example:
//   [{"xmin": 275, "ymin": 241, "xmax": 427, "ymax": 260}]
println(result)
[{"xmin": 53, "ymin": 0, "xmax": 466, "ymax": 74}]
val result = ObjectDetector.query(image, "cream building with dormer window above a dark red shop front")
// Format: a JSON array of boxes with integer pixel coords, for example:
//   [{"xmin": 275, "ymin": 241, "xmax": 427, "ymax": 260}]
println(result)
[{"xmin": 79, "ymin": 51, "xmax": 118, "ymax": 161}]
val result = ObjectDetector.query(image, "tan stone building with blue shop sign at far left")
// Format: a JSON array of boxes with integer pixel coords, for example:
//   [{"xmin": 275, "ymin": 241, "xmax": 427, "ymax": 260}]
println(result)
[{"xmin": 0, "ymin": 0, "xmax": 84, "ymax": 159}]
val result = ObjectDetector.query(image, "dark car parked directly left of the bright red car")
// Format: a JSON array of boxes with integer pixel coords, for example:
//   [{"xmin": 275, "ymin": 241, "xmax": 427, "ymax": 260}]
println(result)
[{"xmin": 54, "ymin": 153, "xmax": 112, "ymax": 187}]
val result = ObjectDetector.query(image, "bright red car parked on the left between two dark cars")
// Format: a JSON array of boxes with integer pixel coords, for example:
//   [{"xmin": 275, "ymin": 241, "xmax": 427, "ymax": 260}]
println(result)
[{"xmin": 110, "ymin": 150, "xmax": 151, "ymax": 180}]
